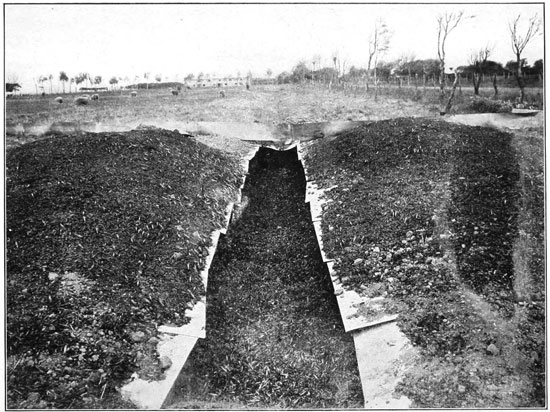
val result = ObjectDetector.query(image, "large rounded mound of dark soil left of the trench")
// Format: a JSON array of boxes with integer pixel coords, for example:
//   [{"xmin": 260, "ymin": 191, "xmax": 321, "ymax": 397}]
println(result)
[{"xmin": 6, "ymin": 130, "xmax": 242, "ymax": 408}]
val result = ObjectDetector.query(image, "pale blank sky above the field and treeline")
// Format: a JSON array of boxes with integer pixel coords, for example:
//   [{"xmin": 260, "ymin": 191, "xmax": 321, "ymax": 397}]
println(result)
[{"xmin": 4, "ymin": 3, "xmax": 544, "ymax": 92}]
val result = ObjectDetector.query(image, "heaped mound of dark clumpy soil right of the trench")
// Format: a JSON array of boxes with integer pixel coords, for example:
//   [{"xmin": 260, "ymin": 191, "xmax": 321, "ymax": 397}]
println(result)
[{"xmin": 306, "ymin": 119, "xmax": 544, "ymax": 407}]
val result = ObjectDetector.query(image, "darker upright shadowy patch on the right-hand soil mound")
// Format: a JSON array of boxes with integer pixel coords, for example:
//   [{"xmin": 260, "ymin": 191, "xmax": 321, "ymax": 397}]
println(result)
[{"xmin": 449, "ymin": 132, "xmax": 519, "ymax": 317}]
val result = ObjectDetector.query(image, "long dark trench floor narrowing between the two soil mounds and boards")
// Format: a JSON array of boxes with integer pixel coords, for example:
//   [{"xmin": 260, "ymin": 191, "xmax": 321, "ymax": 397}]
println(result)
[{"xmin": 166, "ymin": 148, "xmax": 363, "ymax": 409}]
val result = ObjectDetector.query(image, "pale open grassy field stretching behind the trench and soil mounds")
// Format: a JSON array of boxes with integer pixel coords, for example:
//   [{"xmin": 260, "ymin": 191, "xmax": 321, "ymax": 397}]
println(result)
[{"xmin": 6, "ymin": 85, "xmax": 542, "ymax": 142}]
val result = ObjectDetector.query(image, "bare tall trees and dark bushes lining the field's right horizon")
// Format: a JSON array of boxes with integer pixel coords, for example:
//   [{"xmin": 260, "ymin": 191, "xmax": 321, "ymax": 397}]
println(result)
[{"xmin": 277, "ymin": 12, "xmax": 543, "ymax": 112}]
